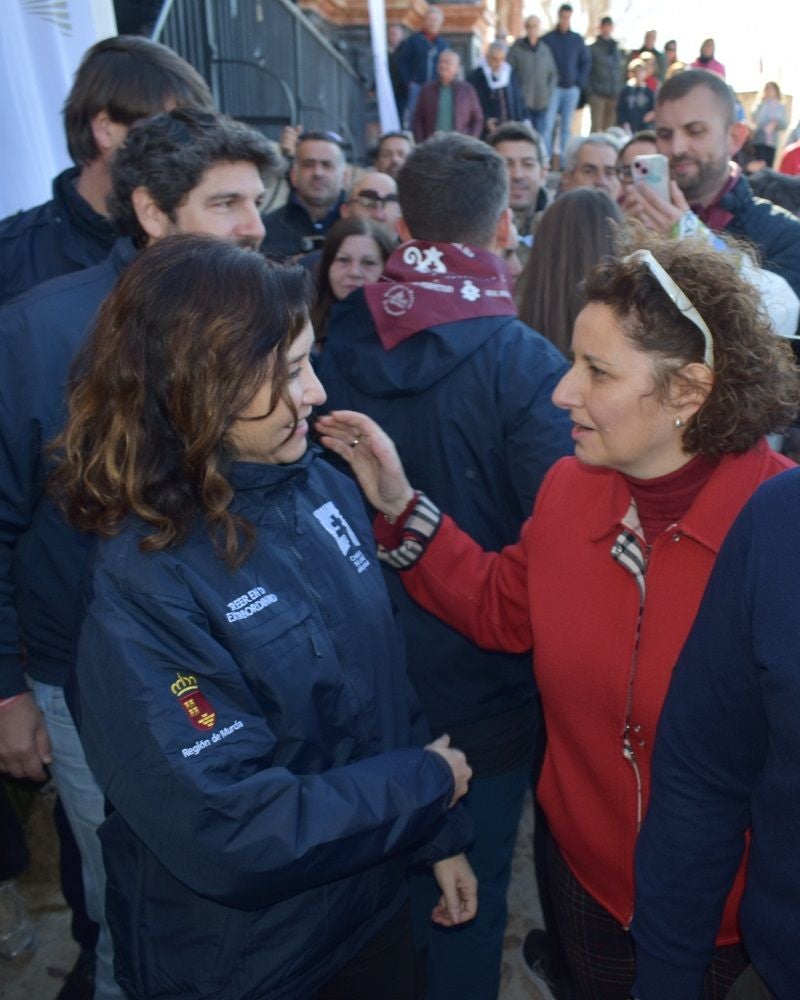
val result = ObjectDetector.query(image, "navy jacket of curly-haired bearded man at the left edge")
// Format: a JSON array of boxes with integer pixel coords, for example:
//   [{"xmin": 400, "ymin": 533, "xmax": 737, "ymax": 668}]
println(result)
[{"xmin": 0, "ymin": 239, "xmax": 135, "ymax": 697}]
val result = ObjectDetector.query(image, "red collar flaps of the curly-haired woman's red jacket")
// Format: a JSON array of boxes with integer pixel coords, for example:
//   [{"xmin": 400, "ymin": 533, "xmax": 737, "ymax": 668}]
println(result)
[{"xmin": 586, "ymin": 440, "xmax": 771, "ymax": 554}]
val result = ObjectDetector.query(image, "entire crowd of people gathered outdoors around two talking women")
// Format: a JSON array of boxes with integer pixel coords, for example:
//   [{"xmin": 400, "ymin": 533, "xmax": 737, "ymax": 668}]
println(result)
[{"xmin": 0, "ymin": 13, "xmax": 800, "ymax": 1000}]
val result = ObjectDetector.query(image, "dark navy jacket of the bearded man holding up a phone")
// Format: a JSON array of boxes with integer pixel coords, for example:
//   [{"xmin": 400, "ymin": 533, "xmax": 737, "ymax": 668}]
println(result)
[{"xmin": 721, "ymin": 176, "xmax": 800, "ymax": 296}]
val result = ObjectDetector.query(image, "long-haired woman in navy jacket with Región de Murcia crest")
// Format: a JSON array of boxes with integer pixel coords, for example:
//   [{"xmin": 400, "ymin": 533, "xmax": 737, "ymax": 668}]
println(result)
[{"xmin": 53, "ymin": 236, "xmax": 477, "ymax": 1000}]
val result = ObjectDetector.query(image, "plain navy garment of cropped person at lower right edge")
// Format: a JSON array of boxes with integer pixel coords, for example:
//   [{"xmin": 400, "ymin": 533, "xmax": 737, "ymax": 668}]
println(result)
[{"xmin": 633, "ymin": 470, "xmax": 800, "ymax": 1000}]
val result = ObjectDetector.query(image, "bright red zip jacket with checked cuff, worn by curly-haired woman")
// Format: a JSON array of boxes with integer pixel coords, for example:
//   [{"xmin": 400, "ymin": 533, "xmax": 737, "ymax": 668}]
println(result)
[{"xmin": 402, "ymin": 444, "xmax": 793, "ymax": 944}]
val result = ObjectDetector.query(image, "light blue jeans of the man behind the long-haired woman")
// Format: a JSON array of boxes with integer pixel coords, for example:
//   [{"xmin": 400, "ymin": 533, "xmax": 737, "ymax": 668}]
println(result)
[{"xmin": 33, "ymin": 681, "xmax": 125, "ymax": 1000}]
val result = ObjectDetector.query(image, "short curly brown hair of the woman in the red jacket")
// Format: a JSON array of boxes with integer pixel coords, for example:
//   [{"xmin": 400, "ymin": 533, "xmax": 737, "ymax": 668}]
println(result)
[{"xmin": 584, "ymin": 230, "xmax": 800, "ymax": 458}]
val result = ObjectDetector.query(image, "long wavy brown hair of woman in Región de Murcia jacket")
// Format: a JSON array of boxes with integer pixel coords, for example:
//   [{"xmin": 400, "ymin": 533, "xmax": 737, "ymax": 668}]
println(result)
[{"xmin": 51, "ymin": 236, "xmax": 310, "ymax": 567}]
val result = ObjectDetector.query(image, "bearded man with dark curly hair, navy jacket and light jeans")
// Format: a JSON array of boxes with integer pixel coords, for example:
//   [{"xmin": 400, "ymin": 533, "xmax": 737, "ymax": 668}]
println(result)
[{"xmin": 0, "ymin": 108, "xmax": 277, "ymax": 1000}]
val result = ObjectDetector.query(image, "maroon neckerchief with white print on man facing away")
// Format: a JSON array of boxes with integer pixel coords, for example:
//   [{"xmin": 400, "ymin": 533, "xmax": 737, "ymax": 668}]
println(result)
[{"xmin": 364, "ymin": 240, "xmax": 517, "ymax": 351}]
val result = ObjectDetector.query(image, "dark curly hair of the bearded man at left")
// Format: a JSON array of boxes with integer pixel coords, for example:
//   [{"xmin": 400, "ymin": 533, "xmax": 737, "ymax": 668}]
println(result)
[{"xmin": 108, "ymin": 108, "xmax": 282, "ymax": 246}]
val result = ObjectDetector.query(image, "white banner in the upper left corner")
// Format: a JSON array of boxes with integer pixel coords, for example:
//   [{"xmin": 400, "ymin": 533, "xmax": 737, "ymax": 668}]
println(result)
[{"xmin": 0, "ymin": 0, "xmax": 117, "ymax": 219}]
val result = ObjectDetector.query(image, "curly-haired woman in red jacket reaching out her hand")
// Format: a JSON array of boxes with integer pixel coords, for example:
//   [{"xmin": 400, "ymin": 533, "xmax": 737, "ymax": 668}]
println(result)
[{"xmin": 320, "ymin": 240, "xmax": 800, "ymax": 1000}]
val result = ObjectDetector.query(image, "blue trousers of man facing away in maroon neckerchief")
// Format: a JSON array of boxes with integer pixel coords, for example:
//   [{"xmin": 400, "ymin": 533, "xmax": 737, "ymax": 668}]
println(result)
[{"xmin": 411, "ymin": 764, "xmax": 531, "ymax": 1000}]
